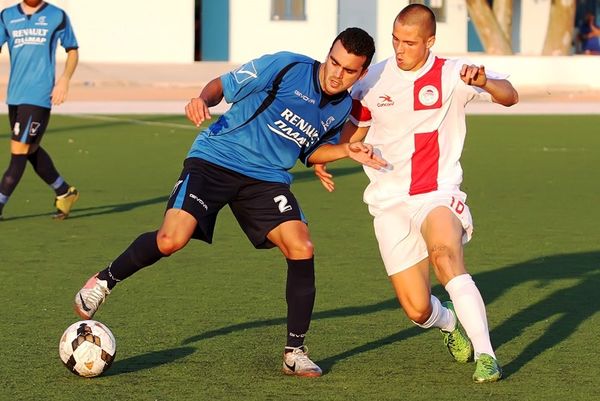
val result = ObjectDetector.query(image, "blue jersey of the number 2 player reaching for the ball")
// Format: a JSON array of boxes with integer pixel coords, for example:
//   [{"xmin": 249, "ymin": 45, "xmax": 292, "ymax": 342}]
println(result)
[{"xmin": 188, "ymin": 52, "xmax": 352, "ymax": 184}]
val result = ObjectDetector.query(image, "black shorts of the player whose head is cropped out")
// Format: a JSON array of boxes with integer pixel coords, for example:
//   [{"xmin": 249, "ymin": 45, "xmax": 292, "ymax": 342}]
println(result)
[{"xmin": 8, "ymin": 104, "xmax": 50, "ymax": 144}]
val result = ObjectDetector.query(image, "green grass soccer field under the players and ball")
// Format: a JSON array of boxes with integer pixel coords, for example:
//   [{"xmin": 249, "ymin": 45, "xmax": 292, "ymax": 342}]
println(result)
[{"xmin": 0, "ymin": 116, "xmax": 600, "ymax": 401}]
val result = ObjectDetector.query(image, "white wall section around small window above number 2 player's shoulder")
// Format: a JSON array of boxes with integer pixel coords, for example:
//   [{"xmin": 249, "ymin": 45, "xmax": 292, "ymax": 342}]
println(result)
[{"xmin": 229, "ymin": 0, "xmax": 338, "ymax": 63}]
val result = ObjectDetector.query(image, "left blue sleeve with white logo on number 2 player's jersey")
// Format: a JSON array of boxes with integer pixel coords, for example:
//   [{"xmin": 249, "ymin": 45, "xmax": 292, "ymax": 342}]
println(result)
[{"xmin": 221, "ymin": 54, "xmax": 283, "ymax": 103}]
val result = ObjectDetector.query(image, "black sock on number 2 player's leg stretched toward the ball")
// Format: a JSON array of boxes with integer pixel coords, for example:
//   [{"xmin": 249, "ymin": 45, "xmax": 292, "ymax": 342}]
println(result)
[{"xmin": 98, "ymin": 231, "xmax": 166, "ymax": 289}]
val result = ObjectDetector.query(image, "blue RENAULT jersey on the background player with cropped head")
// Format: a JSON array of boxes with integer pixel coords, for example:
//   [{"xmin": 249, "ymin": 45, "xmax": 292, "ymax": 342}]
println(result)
[{"xmin": 0, "ymin": 3, "xmax": 78, "ymax": 108}]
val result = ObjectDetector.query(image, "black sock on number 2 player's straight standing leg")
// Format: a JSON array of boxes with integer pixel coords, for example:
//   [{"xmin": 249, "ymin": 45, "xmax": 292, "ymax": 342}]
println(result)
[{"xmin": 285, "ymin": 257, "xmax": 316, "ymax": 347}]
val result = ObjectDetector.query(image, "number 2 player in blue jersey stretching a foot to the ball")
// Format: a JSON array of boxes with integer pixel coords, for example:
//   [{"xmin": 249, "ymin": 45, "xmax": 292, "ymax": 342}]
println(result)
[{"xmin": 75, "ymin": 28, "xmax": 385, "ymax": 377}]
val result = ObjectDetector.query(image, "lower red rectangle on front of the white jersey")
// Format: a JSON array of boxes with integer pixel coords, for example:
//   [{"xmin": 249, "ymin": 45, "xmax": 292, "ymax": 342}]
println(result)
[{"xmin": 408, "ymin": 130, "xmax": 440, "ymax": 195}]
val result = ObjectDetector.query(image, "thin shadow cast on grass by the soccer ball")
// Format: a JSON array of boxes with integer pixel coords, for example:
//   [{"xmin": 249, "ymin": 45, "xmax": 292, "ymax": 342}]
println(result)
[{"xmin": 103, "ymin": 347, "xmax": 196, "ymax": 376}]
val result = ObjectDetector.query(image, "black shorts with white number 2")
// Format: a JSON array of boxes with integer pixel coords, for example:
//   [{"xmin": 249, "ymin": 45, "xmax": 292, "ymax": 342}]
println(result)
[{"xmin": 167, "ymin": 158, "xmax": 306, "ymax": 248}]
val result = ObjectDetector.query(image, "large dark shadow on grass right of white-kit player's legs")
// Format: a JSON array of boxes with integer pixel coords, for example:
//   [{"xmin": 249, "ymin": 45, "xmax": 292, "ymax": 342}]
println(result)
[{"xmin": 475, "ymin": 252, "xmax": 600, "ymax": 377}]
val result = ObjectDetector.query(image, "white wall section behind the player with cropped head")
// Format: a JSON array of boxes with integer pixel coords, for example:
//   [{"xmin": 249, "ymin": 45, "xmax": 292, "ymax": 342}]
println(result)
[{"xmin": 0, "ymin": 0, "xmax": 194, "ymax": 63}]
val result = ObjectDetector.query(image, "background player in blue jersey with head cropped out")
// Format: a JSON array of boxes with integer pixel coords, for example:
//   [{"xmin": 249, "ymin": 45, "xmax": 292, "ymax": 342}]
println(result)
[{"xmin": 0, "ymin": 0, "xmax": 79, "ymax": 219}]
